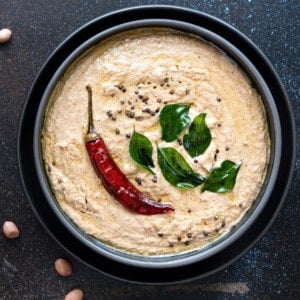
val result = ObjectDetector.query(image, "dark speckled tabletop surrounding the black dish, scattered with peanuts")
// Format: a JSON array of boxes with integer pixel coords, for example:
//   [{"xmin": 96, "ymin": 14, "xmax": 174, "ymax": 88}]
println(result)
[{"xmin": 0, "ymin": 0, "xmax": 300, "ymax": 299}]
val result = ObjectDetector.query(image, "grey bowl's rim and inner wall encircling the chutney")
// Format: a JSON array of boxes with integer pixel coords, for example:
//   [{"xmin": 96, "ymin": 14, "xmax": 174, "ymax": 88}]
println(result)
[{"xmin": 34, "ymin": 19, "xmax": 281, "ymax": 268}]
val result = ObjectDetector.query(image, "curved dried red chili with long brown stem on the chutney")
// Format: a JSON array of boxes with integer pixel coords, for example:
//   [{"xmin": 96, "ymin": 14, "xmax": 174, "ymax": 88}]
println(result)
[{"xmin": 85, "ymin": 85, "xmax": 174, "ymax": 215}]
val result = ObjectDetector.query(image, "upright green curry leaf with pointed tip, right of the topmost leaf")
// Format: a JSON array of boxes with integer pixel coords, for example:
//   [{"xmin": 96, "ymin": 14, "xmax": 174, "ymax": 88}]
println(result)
[{"xmin": 183, "ymin": 114, "xmax": 211, "ymax": 157}]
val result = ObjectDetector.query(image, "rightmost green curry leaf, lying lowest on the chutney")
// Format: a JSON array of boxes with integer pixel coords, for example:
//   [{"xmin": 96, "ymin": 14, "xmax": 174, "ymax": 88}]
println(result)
[{"xmin": 201, "ymin": 160, "xmax": 241, "ymax": 193}]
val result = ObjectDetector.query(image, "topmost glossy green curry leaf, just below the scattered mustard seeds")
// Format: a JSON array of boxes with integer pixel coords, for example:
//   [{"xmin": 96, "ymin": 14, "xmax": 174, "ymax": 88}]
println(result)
[{"xmin": 159, "ymin": 104, "xmax": 191, "ymax": 142}]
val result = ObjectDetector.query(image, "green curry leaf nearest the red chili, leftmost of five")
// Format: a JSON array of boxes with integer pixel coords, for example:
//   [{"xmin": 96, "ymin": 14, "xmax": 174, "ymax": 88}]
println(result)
[{"xmin": 129, "ymin": 130, "xmax": 154, "ymax": 174}]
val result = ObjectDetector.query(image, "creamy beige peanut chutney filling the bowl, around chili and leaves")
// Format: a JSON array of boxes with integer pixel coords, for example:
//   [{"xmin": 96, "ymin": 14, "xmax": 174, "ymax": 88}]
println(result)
[{"xmin": 41, "ymin": 28, "xmax": 269, "ymax": 255}]
